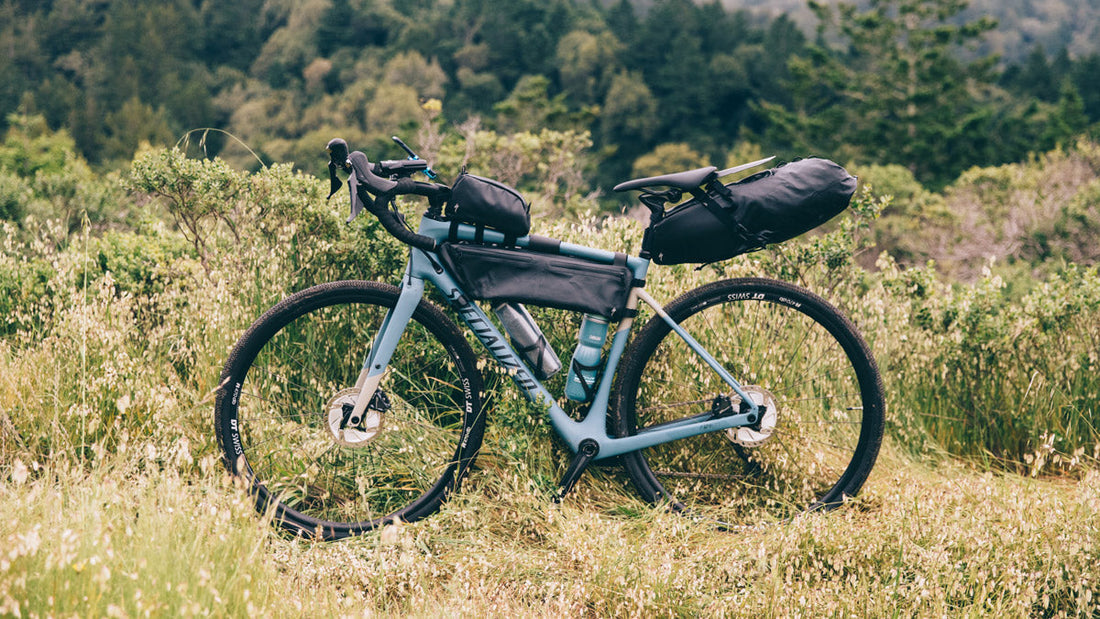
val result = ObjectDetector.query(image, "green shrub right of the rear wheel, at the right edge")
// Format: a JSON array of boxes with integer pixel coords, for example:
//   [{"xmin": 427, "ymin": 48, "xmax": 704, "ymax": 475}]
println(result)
[{"xmin": 877, "ymin": 261, "xmax": 1100, "ymax": 473}]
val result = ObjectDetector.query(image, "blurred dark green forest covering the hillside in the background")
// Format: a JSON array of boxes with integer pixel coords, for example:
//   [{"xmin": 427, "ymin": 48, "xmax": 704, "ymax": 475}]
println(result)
[{"xmin": 0, "ymin": 0, "xmax": 1100, "ymax": 190}]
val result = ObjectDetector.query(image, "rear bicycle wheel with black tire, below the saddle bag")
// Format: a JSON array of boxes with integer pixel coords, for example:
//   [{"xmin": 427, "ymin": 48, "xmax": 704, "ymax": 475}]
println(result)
[{"xmin": 614, "ymin": 278, "xmax": 884, "ymax": 526}]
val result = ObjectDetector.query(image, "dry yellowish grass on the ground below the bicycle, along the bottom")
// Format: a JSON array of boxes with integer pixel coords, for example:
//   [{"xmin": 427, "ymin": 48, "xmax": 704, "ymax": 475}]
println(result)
[{"xmin": 0, "ymin": 447, "xmax": 1100, "ymax": 617}]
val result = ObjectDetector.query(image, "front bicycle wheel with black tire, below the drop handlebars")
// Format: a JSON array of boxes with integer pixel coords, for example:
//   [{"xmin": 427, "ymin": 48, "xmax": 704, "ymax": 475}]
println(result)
[{"xmin": 215, "ymin": 281, "xmax": 485, "ymax": 540}]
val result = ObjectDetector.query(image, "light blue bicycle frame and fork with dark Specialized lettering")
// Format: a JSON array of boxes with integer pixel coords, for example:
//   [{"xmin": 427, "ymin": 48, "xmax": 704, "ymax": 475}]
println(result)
[{"xmin": 347, "ymin": 218, "xmax": 760, "ymax": 460}]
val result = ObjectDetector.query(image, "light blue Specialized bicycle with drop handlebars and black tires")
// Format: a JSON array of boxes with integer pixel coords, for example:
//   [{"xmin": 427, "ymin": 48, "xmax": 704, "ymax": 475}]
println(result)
[{"xmin": 216, "ymin": 137, "xmax": 884, "ymax": 540}]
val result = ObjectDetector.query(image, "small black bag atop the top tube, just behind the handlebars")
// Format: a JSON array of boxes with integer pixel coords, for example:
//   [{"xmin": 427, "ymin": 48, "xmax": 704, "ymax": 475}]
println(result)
[{"xmin": 446, "ymin": 173, "xmax": 531, "ymax": 237}]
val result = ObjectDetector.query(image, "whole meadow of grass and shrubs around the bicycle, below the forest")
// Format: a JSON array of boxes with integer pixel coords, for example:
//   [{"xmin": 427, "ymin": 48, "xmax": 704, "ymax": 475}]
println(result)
[{"xmin": 0, "ymin": 123, "xmax": 1100, "ymax": 617}]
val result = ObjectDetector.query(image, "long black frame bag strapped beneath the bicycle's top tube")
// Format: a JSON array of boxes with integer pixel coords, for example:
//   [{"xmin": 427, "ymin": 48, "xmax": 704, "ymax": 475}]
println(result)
[{"xmin": 439, "ymin": 243, "xmax": 634, "ymax": 320}]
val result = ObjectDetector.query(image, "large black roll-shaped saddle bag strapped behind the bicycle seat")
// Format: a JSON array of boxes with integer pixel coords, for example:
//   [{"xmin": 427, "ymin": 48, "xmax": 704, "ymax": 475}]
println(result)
[{"xmin": 644, "ymin": 158, "xmax": 856, "ymax": 264}]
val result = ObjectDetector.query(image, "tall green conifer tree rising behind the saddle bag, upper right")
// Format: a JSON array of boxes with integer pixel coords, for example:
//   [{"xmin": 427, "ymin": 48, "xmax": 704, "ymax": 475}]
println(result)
[{"xmin": 760, "ymin": 0, "xmax": 996, "ymax": 183}]
